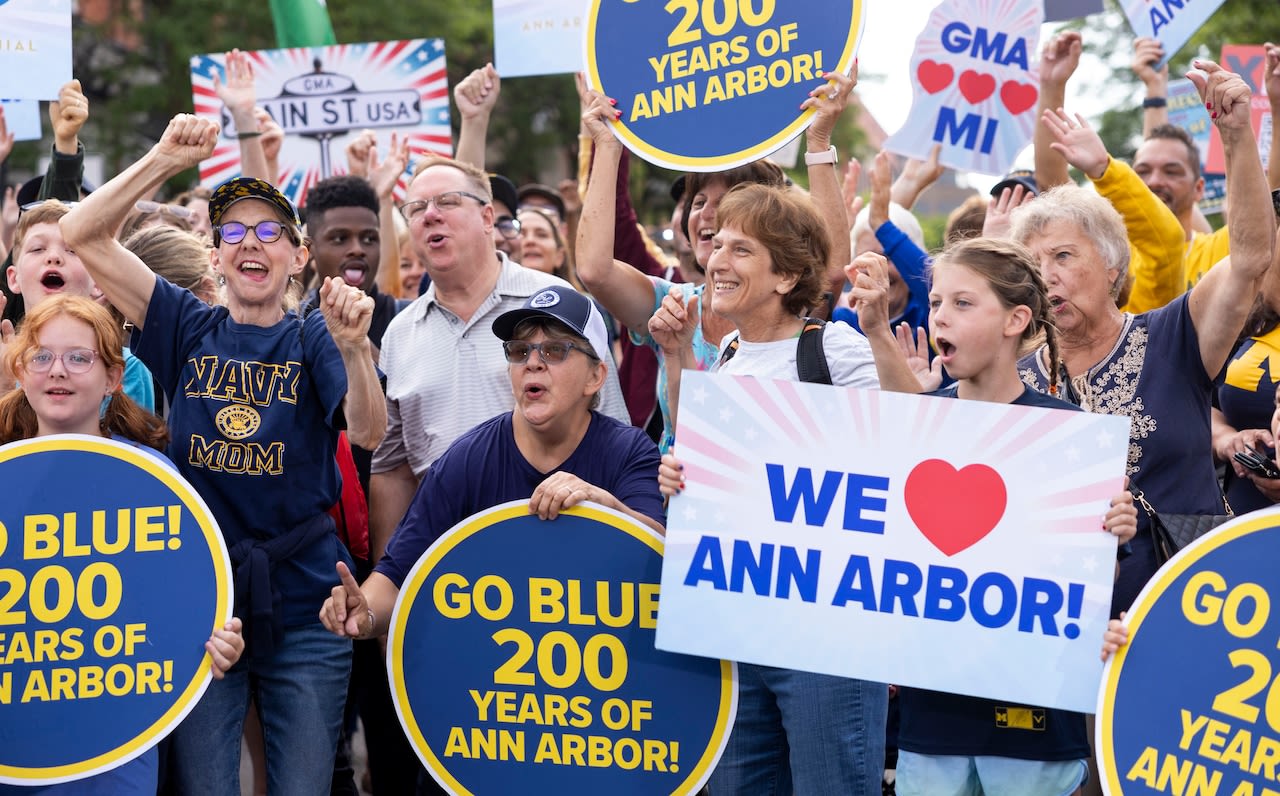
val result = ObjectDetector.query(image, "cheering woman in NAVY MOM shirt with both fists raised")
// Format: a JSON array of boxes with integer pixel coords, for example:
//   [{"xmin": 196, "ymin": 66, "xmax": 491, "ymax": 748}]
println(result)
[{"xmin": 61, "ymin": 114, "xmax": 387, "ymax": 793}]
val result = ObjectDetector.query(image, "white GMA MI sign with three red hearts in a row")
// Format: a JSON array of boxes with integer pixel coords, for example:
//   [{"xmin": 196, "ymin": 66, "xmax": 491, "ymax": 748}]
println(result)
[{"xmin": 885, "ymin": 0, "xmax": 1044, "ymax": 175}]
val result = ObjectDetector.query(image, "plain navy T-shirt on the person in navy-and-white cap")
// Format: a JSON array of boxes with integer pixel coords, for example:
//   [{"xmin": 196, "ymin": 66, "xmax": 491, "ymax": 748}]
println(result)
[{"xmin": 376, "ymin": 412, "xmax": 667, "ymax": 586}]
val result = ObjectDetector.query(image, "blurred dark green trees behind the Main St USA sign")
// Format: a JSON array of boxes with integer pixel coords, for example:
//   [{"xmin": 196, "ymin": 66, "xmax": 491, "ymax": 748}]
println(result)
[{"xmin": 12, "ymin": 0, "xmax": 863, "ymax": 220}]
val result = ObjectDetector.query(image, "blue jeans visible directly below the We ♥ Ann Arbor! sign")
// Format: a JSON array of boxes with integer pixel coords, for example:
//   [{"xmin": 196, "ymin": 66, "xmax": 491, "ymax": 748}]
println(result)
[{"xmin": 710, "ymin": 663, "xmax": 888, "ymax": 796}]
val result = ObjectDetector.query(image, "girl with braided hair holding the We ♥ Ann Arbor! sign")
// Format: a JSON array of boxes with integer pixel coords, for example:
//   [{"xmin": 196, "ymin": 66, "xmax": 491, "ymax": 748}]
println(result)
[{"xmin": 897, "ymin": 238, "xmax": 1138, "ymax": 796}]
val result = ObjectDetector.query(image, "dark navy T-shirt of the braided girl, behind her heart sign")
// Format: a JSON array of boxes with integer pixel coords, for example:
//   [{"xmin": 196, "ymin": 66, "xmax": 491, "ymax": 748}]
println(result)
[{"xmin": 897, "ymin": 385, "xmax": 1089, "ymax": 761}]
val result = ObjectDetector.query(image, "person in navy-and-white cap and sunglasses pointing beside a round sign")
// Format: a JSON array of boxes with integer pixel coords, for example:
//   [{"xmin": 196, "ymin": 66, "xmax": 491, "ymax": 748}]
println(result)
[{"xmin": 320, "ymin": 285, "xmax": 666, "ymax": 639}]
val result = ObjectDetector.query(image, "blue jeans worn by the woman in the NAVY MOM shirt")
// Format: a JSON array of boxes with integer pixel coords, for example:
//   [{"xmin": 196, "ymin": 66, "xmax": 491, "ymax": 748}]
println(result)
[{"xmin": 170, "ymin": 622, "xmax": 351, "ymax": 796}]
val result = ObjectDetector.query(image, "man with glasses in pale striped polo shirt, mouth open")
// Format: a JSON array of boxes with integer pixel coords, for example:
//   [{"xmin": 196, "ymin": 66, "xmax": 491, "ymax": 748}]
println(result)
[{"xmin": 369, "ymin": 156, "xmax": 629, "ymax": 561}]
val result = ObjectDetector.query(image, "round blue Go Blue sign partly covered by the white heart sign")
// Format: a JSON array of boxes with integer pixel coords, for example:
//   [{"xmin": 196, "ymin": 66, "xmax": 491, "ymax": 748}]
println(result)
[{"xmin": 388, "ymin": 500, "xmax": 737, "ymax": 796}]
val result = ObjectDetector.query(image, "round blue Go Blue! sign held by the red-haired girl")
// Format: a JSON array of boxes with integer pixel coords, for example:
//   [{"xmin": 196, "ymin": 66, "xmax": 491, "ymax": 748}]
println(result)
[{"xmin": 0, "ymin": 435, "xmax": 232, "ymax": 784}]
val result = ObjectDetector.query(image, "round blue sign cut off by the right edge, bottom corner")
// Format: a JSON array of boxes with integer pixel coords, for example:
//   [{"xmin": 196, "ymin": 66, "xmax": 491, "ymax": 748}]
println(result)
[{"xmin": 1096, "ymin": 508, "xmax": 1280, "ymax": 796}]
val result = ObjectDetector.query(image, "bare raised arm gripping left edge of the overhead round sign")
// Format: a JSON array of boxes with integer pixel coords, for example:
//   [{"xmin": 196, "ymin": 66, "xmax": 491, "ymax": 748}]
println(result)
[{"xmin": 575, "ymin": 91, "xmax": 665, "ymax": 329}]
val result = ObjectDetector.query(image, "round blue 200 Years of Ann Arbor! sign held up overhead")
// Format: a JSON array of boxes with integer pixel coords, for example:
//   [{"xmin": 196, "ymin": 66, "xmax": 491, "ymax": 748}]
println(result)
[{"xmin": 585, "ymin": 0, "xmax": 865, "ymax": 171}]
